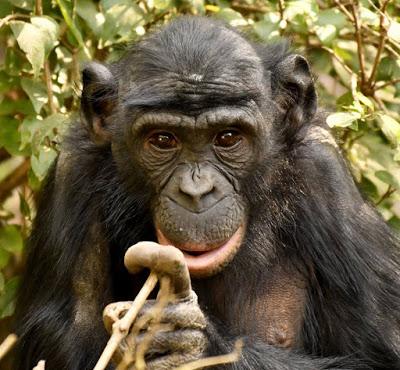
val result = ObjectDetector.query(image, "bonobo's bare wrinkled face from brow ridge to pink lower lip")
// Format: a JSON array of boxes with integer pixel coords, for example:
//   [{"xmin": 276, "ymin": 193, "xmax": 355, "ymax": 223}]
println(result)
[{"xmin": 119, "ymin": 103, "xmax": 266, "ymax": 277}]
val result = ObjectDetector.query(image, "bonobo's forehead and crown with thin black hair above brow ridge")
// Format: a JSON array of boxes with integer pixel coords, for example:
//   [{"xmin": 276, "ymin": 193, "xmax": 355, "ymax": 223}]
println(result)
[{"xmin": 120, "ymin": 17, "xmax": 263, "ymax": 110}]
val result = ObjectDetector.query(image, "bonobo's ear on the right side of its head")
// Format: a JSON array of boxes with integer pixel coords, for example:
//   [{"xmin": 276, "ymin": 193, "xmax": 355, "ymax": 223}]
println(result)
[{"xmin": 272, "ymin": 54, "xmax": 317, "ymax": 124}]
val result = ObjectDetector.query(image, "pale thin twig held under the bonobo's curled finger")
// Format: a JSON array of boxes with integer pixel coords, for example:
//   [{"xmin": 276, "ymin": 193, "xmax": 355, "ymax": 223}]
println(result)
[{"xmin": 94, "ymin": 272, "xmax": 158, "ymax": 370}]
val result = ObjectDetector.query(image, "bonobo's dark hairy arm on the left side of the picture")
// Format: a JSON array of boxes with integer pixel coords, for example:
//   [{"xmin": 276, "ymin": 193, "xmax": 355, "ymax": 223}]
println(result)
[{"xmin": 14, "ymin": 154, "xmax": 110, "ymax": 370}]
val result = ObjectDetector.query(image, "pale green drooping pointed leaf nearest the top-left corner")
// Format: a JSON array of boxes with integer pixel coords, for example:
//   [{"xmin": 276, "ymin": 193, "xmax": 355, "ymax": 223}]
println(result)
[{"xmin": 10, "ymin": 21, "xmax": 45, "ymax": 77}]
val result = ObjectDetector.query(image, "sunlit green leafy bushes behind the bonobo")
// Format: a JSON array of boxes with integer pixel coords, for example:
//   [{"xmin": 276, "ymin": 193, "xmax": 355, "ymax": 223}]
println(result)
[{"xmin": 0, "ymin": 0, "xmax": 400, "ymax": 350}]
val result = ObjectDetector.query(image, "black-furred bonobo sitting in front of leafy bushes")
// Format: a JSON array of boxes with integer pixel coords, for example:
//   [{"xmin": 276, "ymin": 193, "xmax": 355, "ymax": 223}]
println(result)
[{"xmin": 16, "ymin": 17, "xmax": 400, "ymax": 370}]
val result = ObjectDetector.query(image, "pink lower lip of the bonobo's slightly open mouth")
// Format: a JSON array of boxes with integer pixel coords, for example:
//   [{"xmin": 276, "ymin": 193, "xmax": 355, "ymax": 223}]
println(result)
[{"xmin": 157, "ymin": 225, "xmax": 245, "ymax": 278}]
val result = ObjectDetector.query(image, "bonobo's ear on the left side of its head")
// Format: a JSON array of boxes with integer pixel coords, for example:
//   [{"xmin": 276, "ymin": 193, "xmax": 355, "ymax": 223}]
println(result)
[{"xmin": 81, "ymin": 62, "xmax": 118, "ymax": 145}]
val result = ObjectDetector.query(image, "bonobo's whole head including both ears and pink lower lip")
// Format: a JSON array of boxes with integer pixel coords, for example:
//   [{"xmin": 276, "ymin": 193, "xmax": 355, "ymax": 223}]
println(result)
[{"xmin": 82, "ymin": 17, "xmax": 316, "ymax": 277}]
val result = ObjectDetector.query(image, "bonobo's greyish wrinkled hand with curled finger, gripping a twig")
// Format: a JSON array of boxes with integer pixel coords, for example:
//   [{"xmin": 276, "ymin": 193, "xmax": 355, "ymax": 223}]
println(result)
[{"xmin": 104, "ymin": 242, "xmax": 208, "ymax": 370}]
